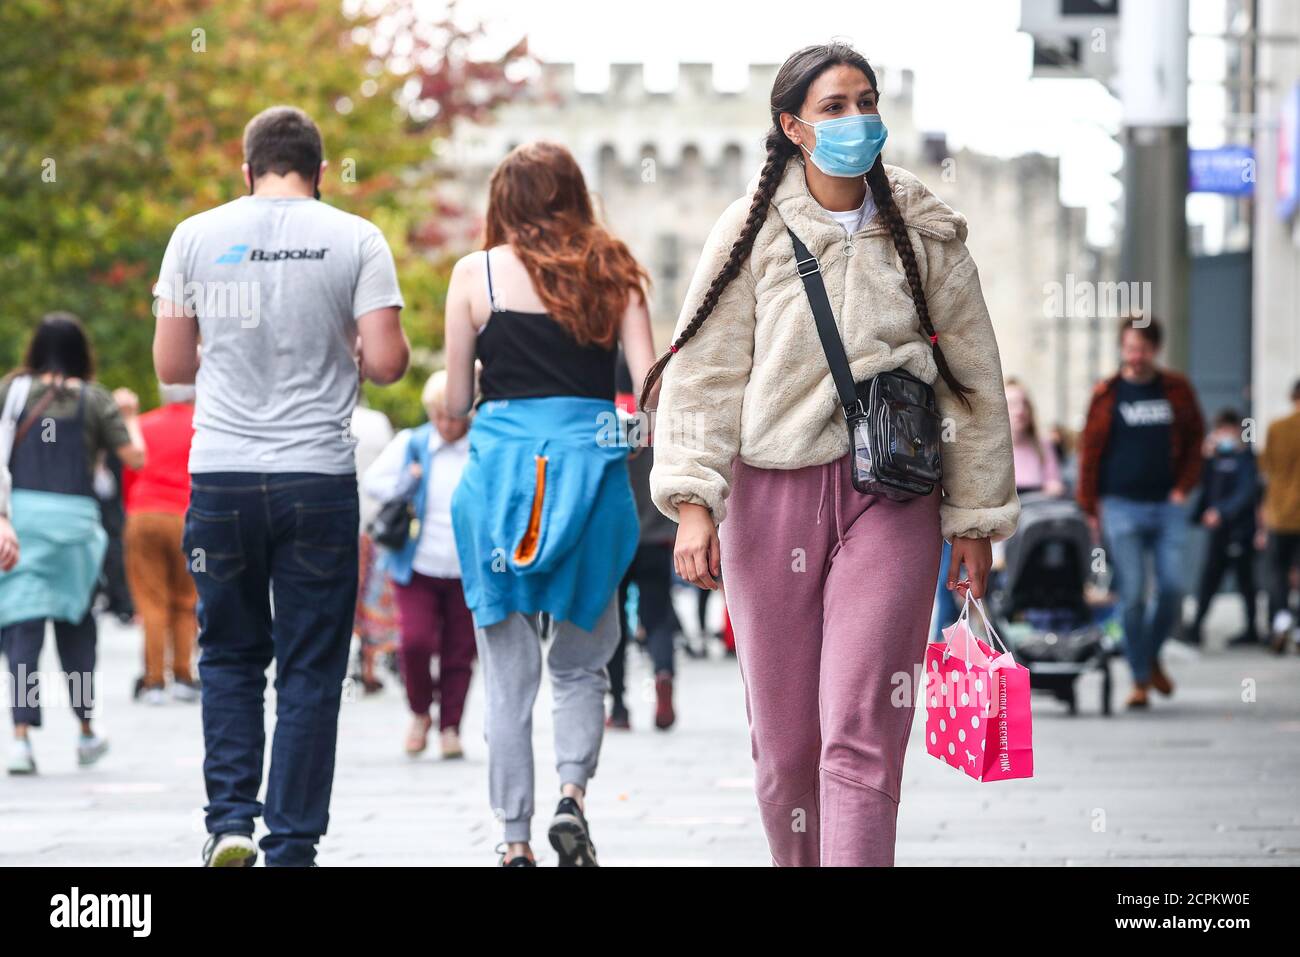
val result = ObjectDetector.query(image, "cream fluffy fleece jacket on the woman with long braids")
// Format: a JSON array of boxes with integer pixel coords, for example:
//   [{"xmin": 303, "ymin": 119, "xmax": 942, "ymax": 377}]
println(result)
[{"xmin": 650, "ymin": 157, "xmax": 1021, "ymax": 541}]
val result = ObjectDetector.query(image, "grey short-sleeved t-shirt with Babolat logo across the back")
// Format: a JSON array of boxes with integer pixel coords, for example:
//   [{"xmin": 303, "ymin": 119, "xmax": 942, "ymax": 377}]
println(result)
[{"xmin": 157, "ymin": 161, "xmax": 402, "ymax": 475}]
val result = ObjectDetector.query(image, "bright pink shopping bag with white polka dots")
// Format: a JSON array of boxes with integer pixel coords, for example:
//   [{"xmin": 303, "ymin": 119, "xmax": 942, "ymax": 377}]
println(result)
[{"xmin": 926, "ymin": 594, "xmax": 1034, "ymax": 781}]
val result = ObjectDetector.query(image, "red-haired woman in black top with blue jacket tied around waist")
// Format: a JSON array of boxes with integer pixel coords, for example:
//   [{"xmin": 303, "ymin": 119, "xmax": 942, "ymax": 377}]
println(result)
[{"xmin": 446, "ymin": 143, "xmax": 654, "ymax": 867}]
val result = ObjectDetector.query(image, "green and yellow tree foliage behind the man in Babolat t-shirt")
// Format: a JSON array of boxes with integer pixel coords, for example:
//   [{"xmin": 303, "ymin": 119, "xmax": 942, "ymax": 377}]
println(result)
[{"xmin": 0, "ymin": 0, "xmax": 528, "ymax": 424}]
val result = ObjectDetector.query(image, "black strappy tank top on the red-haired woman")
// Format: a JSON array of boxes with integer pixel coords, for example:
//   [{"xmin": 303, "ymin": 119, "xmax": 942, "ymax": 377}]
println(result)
[{"xmin": 477, "ymin": 252, "xmax": 619, "ymax": 402}]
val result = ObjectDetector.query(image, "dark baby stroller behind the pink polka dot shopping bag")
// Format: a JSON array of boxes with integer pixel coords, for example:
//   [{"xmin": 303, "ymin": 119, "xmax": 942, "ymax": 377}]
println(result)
[{"xmin": 992, "ymin": 494, "xmax": 1118, "ymax": 715}]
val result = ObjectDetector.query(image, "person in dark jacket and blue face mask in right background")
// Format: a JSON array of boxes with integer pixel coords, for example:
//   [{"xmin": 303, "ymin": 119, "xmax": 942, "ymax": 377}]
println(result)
[{"xmin": 1187, "ymin": 408, "xmax": 1260, "ymax": 645}]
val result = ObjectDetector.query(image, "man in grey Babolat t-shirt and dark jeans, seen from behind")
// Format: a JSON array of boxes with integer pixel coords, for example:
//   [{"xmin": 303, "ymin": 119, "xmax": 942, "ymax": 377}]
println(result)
[{"xmin": 153, "ymin": 107, "xmax": 410, "ymax": 867}]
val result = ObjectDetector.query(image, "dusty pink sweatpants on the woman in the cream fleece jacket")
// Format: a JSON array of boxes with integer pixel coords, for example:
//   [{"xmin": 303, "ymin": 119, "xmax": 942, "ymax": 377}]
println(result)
[{"xmin": 719, "ymin": 455, "xmax": 943, "ymax": 867}]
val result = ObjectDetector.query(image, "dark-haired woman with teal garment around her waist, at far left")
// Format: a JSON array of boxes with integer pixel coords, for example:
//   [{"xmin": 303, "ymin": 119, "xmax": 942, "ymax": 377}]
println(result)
[{"xmin": 0, "ymin": 312, "xmax": 144, "ymax": 775}]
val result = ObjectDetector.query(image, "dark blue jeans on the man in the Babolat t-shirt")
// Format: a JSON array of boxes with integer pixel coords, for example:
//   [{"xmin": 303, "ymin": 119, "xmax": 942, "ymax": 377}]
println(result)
[{"xmin": 185, "ymin": 472, "xmax": 359, "ymax": 866}]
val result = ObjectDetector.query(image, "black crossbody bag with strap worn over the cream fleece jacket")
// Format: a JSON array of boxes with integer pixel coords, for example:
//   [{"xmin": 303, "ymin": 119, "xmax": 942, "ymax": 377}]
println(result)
[{"xmin": 787, "ymin": 229, "xmax": 943, "ymax": 502}]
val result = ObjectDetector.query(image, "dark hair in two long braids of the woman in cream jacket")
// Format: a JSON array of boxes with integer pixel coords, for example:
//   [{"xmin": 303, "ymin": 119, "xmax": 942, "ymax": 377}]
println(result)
[{"xmin": 637, "ymin": 43, "xmax": 974, "ymax": 410}]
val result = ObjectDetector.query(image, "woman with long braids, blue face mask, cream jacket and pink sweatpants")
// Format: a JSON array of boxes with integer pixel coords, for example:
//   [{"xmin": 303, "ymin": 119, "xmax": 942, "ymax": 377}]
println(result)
[{"xmin": 641, "ymin": 44, "xmax": 1019, "ymax": 866}]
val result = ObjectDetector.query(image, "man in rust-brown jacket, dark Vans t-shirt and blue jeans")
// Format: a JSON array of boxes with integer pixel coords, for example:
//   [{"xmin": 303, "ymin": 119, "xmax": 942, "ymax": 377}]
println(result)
[{"xmin": 1076, "ymin": 317, "xmax": 1205, "ymax": 707}]
